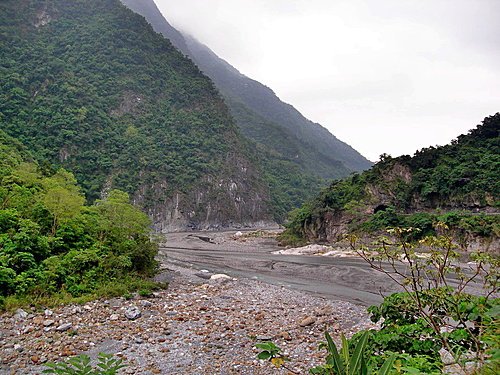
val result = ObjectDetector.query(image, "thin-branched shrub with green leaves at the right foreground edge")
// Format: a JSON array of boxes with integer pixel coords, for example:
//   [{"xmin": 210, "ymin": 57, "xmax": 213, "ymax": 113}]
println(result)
[{"xmin": 351, "ymin": 228, "xmax": 500, "ymax": 371}]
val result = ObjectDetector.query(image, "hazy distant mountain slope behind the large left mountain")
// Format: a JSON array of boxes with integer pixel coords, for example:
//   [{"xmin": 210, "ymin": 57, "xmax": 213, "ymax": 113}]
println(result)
[{"xmin": 122, "ymin": 0, "xmax": 372, "ymax": 220}]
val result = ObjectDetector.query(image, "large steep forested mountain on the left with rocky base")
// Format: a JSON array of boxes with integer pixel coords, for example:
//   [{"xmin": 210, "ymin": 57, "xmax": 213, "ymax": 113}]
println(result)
[{"xmin": 0, "ymin": 0, "xmax": 272, "ymax": 231}]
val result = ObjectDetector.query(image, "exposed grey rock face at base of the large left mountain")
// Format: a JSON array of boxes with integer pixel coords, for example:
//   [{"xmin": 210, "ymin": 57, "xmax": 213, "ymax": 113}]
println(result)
[{"xmin": 137, "ymin": 153, "xmax": 273, "ymax": 233}]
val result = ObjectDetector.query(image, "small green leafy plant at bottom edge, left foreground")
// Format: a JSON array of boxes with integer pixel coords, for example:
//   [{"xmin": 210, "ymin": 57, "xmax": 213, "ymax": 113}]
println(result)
[{"xmin": 43, "ymin": 353, "xmax": 127, "ymax": 375}]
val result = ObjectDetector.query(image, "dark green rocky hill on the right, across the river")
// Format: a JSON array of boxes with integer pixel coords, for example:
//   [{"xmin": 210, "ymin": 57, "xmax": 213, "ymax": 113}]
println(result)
[{"xmin": 284, "ymin": 113, "xmax": 500, "ymax": 250}]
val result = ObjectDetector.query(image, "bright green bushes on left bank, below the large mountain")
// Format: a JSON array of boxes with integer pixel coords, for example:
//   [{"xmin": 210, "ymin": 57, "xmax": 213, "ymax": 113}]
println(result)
[{"xmin": 0, "ymin": 131, "xmax": 157, "ymax": 308}]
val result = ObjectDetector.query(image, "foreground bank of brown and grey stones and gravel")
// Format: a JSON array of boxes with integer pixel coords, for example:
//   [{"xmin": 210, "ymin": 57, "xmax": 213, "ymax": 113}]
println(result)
[{"xmin": 0, "ymin": 265, "xmax": 371, "ymax": 375}]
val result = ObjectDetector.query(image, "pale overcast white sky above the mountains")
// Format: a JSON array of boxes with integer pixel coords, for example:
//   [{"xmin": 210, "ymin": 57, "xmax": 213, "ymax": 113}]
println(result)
[{"xmin": 155, "ymin": 0, "xmax": 500, "ymax": 161}]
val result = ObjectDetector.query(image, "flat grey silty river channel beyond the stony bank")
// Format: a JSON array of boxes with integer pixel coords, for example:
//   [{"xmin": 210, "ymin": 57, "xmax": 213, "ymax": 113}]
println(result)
[{"xmin": 160, "ymin": 231, "xmax": 396, "ymax": 306}]
